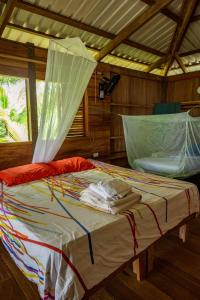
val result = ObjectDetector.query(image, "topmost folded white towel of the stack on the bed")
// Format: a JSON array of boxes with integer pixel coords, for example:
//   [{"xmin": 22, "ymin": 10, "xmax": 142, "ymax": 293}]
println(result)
[{"xmin": 89, "ymin": 179, "xmax": 132, "ymax": 201}]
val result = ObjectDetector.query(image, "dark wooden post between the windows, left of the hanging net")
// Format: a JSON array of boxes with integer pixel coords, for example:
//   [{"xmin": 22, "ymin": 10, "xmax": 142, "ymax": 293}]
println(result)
[{"xmin": 27, "ymin": 43, "xmax": 38, "ymax": 151}]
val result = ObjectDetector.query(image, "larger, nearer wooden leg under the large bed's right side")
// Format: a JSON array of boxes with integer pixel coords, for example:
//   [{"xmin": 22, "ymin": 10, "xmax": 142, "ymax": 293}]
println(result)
[{"xmin": 133, "ymin": 246, "xmax": 154, "ymax": 281}]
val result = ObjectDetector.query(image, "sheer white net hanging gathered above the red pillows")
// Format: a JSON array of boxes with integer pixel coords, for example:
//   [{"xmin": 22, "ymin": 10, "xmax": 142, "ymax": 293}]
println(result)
[{"xmin": 33, "ymin": 38, "xmax": 97, "ymax": 163}]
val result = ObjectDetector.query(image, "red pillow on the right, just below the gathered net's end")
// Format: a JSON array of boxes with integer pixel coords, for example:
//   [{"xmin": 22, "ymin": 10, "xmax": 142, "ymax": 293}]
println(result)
[{"xmin": 48, "ymin": 157, "xmax": 95, "ymax": 175}]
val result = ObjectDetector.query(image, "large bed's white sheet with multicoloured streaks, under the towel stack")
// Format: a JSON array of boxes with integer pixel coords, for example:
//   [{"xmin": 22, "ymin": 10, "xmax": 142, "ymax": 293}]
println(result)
[{"xmin": 0, "ymin": 161, "xmax": 199, "ymax": 300}]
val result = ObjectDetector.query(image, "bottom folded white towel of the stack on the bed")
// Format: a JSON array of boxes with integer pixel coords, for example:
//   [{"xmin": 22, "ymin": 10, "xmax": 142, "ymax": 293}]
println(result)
[{"xmin": 80, "ymin": 189, "xmax": 141, "ymax": 214}]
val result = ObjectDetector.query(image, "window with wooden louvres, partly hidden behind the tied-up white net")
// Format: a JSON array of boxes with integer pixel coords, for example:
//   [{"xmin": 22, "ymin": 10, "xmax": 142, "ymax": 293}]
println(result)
[{"xmin": 36, "ymin": 80, "xmax": 85, "ymax": 137}]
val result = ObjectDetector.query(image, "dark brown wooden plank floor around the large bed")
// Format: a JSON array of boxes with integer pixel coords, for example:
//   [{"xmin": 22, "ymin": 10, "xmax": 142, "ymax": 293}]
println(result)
[{"xmin": 0, "ymin": 219, "xmax": 200, "ymax": 300}]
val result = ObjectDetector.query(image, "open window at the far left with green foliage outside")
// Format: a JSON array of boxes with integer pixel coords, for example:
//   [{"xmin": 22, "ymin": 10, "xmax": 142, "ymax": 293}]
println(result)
[{"xmin": 0, "ymin": 75, "xmax": 29, "ymax": 143}]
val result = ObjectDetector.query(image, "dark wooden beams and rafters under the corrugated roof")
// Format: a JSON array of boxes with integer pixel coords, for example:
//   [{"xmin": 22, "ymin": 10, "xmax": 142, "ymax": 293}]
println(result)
[{"xmin": 0, "ymin": 0, "xmax": 200, "ymax": 76}]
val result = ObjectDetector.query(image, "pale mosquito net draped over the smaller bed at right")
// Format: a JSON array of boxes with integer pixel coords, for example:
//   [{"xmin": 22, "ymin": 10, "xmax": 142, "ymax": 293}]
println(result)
[{"xmin": 122, "ymin": 111, "xmax": 200, "ymax": 178}]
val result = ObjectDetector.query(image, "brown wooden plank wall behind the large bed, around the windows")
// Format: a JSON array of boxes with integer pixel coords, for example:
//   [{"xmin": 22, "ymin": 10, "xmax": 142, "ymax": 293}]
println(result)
[{"xmin": 0, "ymin": 39, "xmax": 162, "ymax": 169}]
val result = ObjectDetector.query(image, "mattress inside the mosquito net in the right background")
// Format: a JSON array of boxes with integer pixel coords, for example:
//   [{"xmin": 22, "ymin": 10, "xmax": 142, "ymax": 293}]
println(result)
[{"xmin": 134, "ymin": 156, "xmax": 200, "ymax": 177}]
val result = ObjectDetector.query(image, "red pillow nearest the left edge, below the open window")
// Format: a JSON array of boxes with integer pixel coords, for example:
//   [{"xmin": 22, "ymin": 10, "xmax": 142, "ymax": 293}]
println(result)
[{"xmin": 0, "ymin": 163, "xmax": 56, "ymax": 186}]
